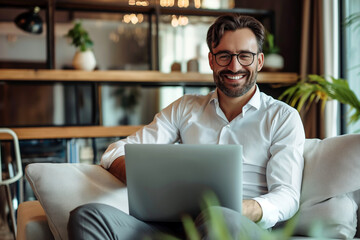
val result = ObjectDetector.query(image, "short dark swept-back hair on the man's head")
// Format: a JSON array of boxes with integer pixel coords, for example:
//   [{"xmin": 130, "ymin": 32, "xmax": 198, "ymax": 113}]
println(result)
[{"xmin": 206, "ymin": 14, "xmax": 265, "ymax": 53}]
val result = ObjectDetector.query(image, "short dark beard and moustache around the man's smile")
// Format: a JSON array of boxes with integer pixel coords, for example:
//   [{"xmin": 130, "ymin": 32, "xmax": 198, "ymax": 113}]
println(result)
[{"xmin": 213, "ymin": 70, "xmax": 258, "ymax": 98}]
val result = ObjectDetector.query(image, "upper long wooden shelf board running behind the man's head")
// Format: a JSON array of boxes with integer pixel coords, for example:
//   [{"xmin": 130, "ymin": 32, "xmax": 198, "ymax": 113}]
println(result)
[{"xmin": 0, "ymin": 69, "xmax": 298, "ymax": 85}]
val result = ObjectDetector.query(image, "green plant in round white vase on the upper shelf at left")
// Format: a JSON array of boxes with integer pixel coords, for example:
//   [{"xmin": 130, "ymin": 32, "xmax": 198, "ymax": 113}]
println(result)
[{"xmin": 65, "ymin": 22, "xmax": 96, "ymax": 71}]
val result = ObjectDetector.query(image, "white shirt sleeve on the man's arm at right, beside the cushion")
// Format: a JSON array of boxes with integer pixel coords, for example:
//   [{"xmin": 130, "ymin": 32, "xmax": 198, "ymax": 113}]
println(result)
[{"xmin": 254, "ymin": 110, "xmax": 305, "ymax": 229}]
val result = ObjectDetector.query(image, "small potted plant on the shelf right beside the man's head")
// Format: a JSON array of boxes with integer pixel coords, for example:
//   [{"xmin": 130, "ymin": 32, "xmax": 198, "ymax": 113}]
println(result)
[{"xmin": 263, "ymin": 32, "xmax": 284, "ymax": 72}]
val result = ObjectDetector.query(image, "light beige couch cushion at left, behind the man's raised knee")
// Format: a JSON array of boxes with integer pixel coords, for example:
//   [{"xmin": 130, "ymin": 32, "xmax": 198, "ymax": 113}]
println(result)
[{"xmin": 25, "ymin": 163, "xmax": 128, "ymax": 240}]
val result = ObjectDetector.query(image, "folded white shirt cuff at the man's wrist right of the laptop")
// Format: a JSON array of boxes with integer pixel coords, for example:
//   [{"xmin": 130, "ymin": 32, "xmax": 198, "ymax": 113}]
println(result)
[{"xmin": 253, "ymin": 197, "xmax": 279, "ymax": 229}]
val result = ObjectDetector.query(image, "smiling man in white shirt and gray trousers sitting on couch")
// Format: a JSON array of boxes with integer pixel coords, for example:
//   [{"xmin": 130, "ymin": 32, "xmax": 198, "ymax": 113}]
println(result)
[{"xmin": 69, "ymin": 15, "xmax": 305, "ymax": 239}]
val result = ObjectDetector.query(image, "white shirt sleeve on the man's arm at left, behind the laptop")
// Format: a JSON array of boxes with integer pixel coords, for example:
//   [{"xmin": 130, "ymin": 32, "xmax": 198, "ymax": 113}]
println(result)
[{"xmin": 100, "ymin": 98, "xmax": 182, "ymax": 169}]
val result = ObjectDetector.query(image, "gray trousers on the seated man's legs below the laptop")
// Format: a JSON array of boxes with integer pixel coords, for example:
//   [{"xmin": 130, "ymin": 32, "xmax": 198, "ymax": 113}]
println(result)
[{"xmin": 68, "ymin": 203, "xmax": 265, "ymax": 240}]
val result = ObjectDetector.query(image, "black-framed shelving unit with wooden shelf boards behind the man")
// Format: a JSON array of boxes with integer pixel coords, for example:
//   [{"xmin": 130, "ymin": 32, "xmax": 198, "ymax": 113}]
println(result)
[{"xmin": 0, "ymin": 0, "xmax": 292, "ymax": 142}]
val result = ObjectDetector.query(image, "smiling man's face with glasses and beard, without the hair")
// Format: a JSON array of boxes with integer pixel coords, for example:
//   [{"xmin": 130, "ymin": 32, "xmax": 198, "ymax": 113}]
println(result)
[{"xmin": 209, "ymin": 28, "xmax": 264, "ymax": 98}]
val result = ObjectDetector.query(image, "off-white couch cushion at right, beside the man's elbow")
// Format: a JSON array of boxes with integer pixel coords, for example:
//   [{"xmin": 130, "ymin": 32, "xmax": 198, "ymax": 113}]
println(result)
[{"xmin": 295, "ymin": 134, "xmax": 360, "ymax": 239}]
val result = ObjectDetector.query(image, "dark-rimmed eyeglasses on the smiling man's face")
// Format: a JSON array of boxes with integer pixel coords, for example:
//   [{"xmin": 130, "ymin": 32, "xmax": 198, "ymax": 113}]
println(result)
[{"xmin": 212, "ymin": 52, "xmax": 257, "ymax": 67}]
